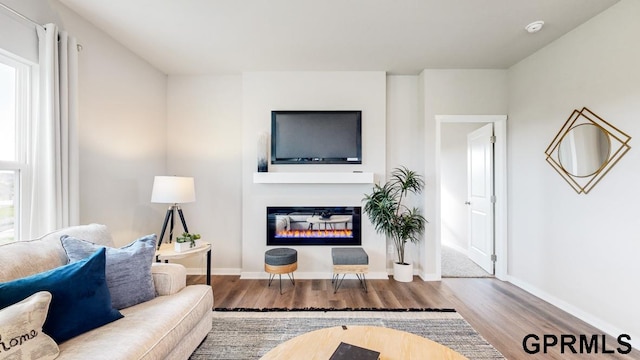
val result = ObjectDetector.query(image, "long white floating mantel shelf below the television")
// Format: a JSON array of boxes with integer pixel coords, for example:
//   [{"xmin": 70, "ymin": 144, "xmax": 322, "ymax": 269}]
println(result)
[{"xmin": 253, "ymin": 172, "xmax": 373, "ymax": 184}]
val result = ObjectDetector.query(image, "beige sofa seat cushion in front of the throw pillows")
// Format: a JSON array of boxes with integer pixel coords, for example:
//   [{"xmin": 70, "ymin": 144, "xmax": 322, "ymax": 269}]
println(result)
[{"xmin": 58, "ymin": 285, "xmax": 213, "ymax": 360}]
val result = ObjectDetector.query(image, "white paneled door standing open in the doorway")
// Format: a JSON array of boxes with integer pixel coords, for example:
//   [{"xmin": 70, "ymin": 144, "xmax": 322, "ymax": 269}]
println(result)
[{"xmin": 467, "ymin": 123, "xmax": 494, "ymax": 274}]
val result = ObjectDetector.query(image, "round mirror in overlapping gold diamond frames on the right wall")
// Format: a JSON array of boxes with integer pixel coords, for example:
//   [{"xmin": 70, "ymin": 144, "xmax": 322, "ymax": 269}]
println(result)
[{"xmin": 545, "ymin": 107, "xmax": 631, "ymax": 194}]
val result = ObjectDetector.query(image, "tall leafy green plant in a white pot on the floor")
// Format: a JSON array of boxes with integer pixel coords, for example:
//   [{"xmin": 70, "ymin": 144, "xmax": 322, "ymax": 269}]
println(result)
[{"xmin": 363, "ymin": 167, "xmax": 427, "ymax": 282}]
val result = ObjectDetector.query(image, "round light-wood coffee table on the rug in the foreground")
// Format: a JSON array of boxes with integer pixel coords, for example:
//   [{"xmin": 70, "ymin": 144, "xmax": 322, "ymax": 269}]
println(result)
[{"xmin": 262, "ymin": 326, "xmax": 467, "ymax": 360}]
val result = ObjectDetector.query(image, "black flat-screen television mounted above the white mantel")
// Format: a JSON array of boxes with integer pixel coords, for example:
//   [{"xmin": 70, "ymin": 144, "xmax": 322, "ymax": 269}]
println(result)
[{"xmin": 271, "ymin": 110, "xmax": 362, "ymax": 164}]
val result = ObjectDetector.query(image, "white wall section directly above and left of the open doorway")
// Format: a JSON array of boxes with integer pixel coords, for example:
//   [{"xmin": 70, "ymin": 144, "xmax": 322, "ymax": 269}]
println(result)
[{"xmin": 419, "ymin": 69, "xmax": 508, "ymax": 280}]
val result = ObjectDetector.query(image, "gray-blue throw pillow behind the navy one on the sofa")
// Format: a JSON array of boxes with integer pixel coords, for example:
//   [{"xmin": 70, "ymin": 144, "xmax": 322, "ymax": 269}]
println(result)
[{"xmin": 60, "ymin": 234, "xmax": 156, "ymax": 309}]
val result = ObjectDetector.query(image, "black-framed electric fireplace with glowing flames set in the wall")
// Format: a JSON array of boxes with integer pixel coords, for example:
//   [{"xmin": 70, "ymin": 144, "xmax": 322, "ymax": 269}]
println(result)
[{"xmin": 267, "ymin": 206, "xmax": 362, "ymax": 246}]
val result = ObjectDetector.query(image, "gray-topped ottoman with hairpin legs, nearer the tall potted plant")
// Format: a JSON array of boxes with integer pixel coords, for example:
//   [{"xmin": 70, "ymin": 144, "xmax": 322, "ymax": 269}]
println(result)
[{"xmin": 331, "ymin": 248, "xmax": 369, "ymax": 294}]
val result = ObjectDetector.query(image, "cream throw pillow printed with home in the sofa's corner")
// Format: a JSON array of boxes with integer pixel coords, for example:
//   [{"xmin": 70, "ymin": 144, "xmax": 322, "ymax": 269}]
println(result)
[{"xmin": 0, "ymin": 291, "xmax": 60, "ymax": 360}]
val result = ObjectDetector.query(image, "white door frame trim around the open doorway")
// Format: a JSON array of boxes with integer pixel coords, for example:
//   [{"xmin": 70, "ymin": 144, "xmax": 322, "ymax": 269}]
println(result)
[{"xmin": 432, "ymin": 115, "xmax": 507, "ymax": 280}]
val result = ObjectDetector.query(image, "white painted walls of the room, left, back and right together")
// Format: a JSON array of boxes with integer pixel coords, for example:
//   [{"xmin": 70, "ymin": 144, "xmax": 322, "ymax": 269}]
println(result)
[{"xmin": 8, "ymin": 0, "xmax": 640, "ymax": 347}]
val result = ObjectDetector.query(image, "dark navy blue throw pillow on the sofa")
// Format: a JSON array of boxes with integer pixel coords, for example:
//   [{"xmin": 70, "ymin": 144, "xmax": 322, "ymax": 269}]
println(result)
[{"xmin": 0, "ymin": 249, "xmax": 122, "ymax": 343}]
